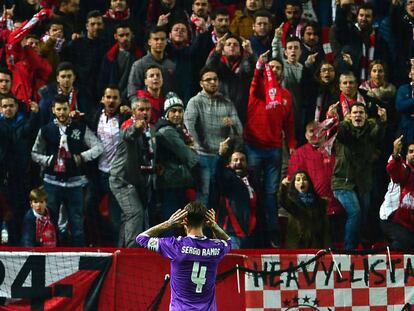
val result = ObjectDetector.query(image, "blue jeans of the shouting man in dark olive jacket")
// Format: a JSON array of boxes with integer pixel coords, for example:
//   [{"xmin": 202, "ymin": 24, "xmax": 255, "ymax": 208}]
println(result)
[{"xmin": 333, "ymin": 189, "xmax": 361, "ymax": 249}]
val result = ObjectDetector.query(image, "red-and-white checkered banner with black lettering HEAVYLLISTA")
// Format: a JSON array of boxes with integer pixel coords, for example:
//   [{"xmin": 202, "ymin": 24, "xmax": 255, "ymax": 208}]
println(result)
[{"xmin": 245, "ymin": 254, "xmax": 414, "ymax": 311}]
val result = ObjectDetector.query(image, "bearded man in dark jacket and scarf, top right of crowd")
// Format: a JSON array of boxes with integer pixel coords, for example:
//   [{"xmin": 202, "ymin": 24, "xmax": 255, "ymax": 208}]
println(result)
[{"xmin": 334, "ymin": 1, "xmax": 389, "ymax": 81}]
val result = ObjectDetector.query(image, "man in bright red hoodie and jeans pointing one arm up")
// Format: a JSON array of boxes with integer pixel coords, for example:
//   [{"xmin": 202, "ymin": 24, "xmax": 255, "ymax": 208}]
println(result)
[{"xmin": 244, "ymin": 51, "xmax": 296, "ymax": 247}]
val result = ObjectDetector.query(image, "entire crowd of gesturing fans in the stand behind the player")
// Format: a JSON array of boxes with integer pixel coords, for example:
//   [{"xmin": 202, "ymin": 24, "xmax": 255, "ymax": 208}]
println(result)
[{"xmin": 0, "ymin": 0, "xmax": 414, "ymax": 249}]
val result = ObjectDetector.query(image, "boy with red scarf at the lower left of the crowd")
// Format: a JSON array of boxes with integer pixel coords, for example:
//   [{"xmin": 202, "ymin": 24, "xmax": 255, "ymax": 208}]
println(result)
[{"xmin": 22, "ymin": 187, "xmax": 57, "ymax": 247}]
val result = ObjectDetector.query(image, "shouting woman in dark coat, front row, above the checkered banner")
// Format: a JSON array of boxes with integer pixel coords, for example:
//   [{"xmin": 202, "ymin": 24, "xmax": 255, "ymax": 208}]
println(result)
[{"xmin": 279, "ymin": 170, "xmax": 330, "ymax": 248}]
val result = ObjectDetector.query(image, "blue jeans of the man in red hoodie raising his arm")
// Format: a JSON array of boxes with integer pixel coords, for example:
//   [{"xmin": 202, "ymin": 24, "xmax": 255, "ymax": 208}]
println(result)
[{"xmin": 246, "ymin": 145, "xmax": 282, "ymax": 244}]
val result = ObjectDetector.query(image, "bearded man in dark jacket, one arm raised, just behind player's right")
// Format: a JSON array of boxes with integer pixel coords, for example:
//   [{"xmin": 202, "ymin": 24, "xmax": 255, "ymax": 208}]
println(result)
[{"xmin": 216, "ymin": 138, "xmax": 256, "ymax": 249}]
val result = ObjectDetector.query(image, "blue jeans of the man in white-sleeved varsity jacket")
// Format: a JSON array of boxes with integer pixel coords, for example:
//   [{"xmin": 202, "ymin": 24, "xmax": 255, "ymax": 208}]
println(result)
[{"xmin": 44, "ymin": 182, "xmax": 85, "ymax": 246}]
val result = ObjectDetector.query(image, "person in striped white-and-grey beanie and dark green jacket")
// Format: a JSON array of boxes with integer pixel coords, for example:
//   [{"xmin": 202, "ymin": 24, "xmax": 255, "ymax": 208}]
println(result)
[{"xmin": 157, "ymin": 92, "xmax": 198, "ymax": 220}]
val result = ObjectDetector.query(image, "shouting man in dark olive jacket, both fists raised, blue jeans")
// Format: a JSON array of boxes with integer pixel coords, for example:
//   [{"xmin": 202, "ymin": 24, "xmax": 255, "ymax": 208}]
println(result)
[{"xmin": 328, "ymin": 102, "xmax": 387, "ymax": 250}]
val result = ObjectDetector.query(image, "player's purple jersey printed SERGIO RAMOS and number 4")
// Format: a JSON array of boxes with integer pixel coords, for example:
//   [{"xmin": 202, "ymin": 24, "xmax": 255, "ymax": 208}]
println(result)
[{"xmin": 136, "ymin": 234, "xmax": 231, "ymax": 311}]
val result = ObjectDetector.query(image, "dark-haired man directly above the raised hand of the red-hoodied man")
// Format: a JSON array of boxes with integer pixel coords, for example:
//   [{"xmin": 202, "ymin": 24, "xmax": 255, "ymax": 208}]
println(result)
[{"xmin": 249, "ymin": 10, "xmax": 272, "ymax": 55}]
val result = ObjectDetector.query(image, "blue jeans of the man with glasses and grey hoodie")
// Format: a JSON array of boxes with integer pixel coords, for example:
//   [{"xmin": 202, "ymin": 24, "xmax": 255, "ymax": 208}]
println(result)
[{"xmin": 197, "ymin": 154, "xmax": 217, "ymax": 206}]
